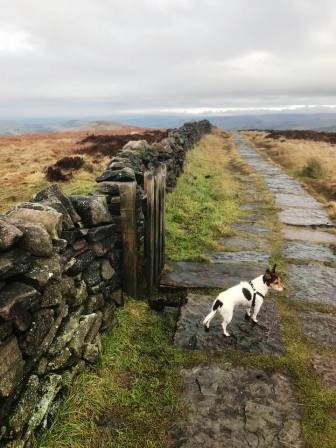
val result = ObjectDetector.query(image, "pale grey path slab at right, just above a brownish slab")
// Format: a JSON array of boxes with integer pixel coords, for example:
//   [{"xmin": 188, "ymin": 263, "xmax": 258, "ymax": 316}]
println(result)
[{"xmin": 279, "ymin": 207, "xmax": 334, "ymax": 227}]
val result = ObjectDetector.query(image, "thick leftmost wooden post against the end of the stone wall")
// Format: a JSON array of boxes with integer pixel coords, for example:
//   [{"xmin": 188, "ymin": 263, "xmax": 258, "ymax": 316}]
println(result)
[{"xmin": 119, "ymin": 182, "xmax": 138, "ymax": 297}]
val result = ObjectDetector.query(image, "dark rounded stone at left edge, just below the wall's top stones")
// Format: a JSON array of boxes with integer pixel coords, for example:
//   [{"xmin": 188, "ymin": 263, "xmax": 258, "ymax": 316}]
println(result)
[{"xmin": 0, "ymin": 248, "xmax": 32, "ymax": 279}]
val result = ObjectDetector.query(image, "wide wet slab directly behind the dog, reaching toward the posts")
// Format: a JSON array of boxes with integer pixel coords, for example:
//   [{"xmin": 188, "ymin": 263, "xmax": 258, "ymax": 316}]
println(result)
[{"xmin": 161, "ymin": 261, "xmax": 261, "ymax": 289}]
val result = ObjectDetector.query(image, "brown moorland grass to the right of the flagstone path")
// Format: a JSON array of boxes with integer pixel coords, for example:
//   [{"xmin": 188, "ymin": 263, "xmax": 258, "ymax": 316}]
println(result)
[{"xmin": 243, "ymin": 131, "xmax": 336, "ymax": 218}]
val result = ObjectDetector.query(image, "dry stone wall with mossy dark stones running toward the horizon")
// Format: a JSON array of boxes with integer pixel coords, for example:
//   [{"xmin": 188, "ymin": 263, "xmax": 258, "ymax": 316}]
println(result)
[{"xmin": 0, "ymin": 120, "xmax": 211, "ymax": 448}]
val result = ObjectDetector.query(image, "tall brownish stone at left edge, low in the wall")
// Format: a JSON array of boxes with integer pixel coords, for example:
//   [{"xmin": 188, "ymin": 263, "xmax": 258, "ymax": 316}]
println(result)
[{"xmin": 0, "ymin": 336, "xmax": 25, "ymax": 397}]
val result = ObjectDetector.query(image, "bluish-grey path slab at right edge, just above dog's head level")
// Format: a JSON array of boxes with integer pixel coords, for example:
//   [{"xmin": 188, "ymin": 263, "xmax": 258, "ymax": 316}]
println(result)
[{"xmin": 282, "ymin": 241, "xmax": 336, "ymax": 264}]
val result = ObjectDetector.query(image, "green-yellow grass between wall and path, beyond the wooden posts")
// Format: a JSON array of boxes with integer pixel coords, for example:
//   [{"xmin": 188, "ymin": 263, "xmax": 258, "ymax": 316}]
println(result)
[{"xmin": 166, "ymin": 130, "xmax": 241, "ymax": 260}]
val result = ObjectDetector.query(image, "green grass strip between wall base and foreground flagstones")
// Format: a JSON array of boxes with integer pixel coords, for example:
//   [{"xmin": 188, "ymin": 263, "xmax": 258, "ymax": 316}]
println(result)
[{"xmin": 37, "ymin": 300, "xmax": 182, "ymax": 448}]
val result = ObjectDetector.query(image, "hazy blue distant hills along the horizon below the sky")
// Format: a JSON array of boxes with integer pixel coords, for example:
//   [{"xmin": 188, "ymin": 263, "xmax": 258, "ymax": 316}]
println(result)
[{"xmin": 0, "ymin": 112, "xmax": 336, "ymax": 135}]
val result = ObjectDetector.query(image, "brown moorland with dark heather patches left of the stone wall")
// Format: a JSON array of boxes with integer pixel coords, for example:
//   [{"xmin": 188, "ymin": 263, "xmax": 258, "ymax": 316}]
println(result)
[{"xmin": 0, "ymin": 123, "xmax": 165, "ymax": 212}]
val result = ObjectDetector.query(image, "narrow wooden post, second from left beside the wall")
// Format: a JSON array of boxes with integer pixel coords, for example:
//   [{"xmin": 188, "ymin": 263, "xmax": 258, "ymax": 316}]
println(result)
[{"xmin": 144, "ymin": 172, "xmax": 155, "ymax": 299}]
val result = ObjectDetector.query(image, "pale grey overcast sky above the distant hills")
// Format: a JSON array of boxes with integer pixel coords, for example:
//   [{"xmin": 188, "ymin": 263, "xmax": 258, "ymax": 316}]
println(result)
[{"xmin": 0, "ymin": 0, "xmax": 336, "ymax": 117}]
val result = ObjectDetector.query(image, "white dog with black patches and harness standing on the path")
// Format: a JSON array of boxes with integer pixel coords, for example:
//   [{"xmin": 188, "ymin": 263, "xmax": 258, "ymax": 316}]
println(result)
[{"xmin": 203, "ymin": 264, "xmax": 284, "ymax": 336}]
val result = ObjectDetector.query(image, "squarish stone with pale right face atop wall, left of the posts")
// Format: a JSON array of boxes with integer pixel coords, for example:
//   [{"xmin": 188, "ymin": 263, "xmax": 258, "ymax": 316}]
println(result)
[{"xmin": 71, "ymin": 195, "xmax": 113, "ymax": 226}]
